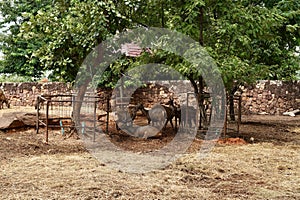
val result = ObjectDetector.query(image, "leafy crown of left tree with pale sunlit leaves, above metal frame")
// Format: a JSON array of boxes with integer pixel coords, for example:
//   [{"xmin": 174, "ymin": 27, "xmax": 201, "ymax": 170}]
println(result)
[{"xmin": 21, "ymin": 0, "xmax": 131, "ymax": 82}]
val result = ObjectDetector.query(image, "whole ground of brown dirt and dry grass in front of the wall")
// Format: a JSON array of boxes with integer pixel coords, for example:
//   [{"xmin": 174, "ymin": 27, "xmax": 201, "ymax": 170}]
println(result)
[{"xmin": 0, "ymin": 105, "xmax": 300, "ymax": 200}]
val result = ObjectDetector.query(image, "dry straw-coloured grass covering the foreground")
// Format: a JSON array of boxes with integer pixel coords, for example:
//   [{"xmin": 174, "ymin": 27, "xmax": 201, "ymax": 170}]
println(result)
[{"xmin": 0, "ymin": 143, "xmax": 300, "ymax": 199}]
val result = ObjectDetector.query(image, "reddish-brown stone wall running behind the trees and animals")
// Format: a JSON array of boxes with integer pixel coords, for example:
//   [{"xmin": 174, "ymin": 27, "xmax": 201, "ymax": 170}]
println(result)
[{"xmin": 0, "ymin": 81, "xmax": 300, "ymax": 115}]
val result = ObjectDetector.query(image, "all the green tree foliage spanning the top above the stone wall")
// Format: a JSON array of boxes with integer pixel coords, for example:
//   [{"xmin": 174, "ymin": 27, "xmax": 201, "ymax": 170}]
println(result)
[{"xmin": 0, "ymin": 0, "xmax": 300, "ymax": 90}]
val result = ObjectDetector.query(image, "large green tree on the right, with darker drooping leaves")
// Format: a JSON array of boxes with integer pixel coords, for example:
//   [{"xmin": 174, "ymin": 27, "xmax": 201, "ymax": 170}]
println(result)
[{"xmin": 123, "ymin": 0, "xmax": 299, "ymax": 122}]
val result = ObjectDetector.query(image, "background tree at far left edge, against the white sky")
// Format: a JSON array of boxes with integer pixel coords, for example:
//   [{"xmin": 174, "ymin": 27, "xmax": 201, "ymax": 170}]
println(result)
[{"xmin": 0, "ymin": 0, "xmax": 52, "ymax": 77}]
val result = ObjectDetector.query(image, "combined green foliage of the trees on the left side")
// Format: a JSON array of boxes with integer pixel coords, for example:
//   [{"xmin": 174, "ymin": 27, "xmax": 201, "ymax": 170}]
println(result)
[{"xmin": 1, "ymin": 0, "xmax": 128, "ymax": 81}]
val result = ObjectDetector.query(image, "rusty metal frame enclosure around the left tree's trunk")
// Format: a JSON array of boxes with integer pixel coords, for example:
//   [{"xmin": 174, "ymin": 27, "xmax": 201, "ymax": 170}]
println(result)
[{"xmin": 36, "ymin": 94, "xmax": 108, "ymax": 143}]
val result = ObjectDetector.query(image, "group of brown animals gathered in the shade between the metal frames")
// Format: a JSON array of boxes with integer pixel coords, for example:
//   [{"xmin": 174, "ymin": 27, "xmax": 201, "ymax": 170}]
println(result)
[{"xmin": 116, "ymin": 98, "xmax": 197, "ymax": 138}]
